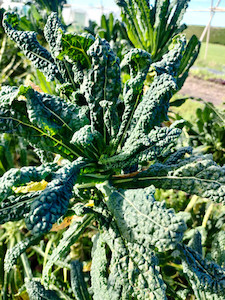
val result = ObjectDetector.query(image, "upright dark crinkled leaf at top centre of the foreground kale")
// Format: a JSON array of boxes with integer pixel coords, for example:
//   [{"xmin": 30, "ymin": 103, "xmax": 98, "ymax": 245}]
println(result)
[{"xmin": 80, "ymin": 38, "xmax": 121, "ymax": 135}]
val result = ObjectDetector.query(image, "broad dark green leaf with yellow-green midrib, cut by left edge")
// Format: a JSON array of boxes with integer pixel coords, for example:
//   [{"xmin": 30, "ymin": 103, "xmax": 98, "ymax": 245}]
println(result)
[{"xmin": 0, "ymin": 86, "xmax": 89, "ymax": 160}]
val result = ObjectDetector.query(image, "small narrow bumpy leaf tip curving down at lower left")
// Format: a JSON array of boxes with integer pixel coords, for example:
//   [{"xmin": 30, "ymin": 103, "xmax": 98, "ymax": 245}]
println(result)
[{"xmin": 4, "ymin": 236, "xmax": 40, "ymax": 272}]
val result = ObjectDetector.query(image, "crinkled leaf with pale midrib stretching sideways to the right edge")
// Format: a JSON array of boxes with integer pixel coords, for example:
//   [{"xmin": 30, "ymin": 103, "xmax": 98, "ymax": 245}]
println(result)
[{"xmin": 125, "ymin": 155, "xmax": 225, "ymax": 203}]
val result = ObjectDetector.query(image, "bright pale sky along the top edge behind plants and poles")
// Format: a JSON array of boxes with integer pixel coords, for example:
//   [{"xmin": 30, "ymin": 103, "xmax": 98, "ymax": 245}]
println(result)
[{"xmin": 67, "ymin": 0, "xmax": 225, "ymax": 28}]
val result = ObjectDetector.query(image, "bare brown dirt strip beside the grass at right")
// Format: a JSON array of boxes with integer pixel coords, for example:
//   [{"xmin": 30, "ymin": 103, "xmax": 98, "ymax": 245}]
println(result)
[{"xmin": 179, "ymin": 76, "xmax": 225, "ymax": 105}]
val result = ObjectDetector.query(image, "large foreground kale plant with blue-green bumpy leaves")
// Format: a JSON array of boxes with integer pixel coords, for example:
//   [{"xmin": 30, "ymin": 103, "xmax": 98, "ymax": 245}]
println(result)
[{"xmin": 0, "ymin": 13, "xmax": 225, "ymax": 300}]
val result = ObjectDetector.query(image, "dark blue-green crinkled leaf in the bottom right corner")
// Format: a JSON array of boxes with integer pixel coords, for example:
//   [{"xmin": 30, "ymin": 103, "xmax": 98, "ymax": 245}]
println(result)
[{"xmin": 179, "ymin": 245, "xmax": 225, "ymax": 300}]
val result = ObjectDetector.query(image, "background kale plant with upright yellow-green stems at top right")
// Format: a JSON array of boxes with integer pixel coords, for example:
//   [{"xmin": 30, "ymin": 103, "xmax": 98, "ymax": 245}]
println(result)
[{"xmin": 115, "ymin": 0, "xmax": 200, "ymax": 89}]
